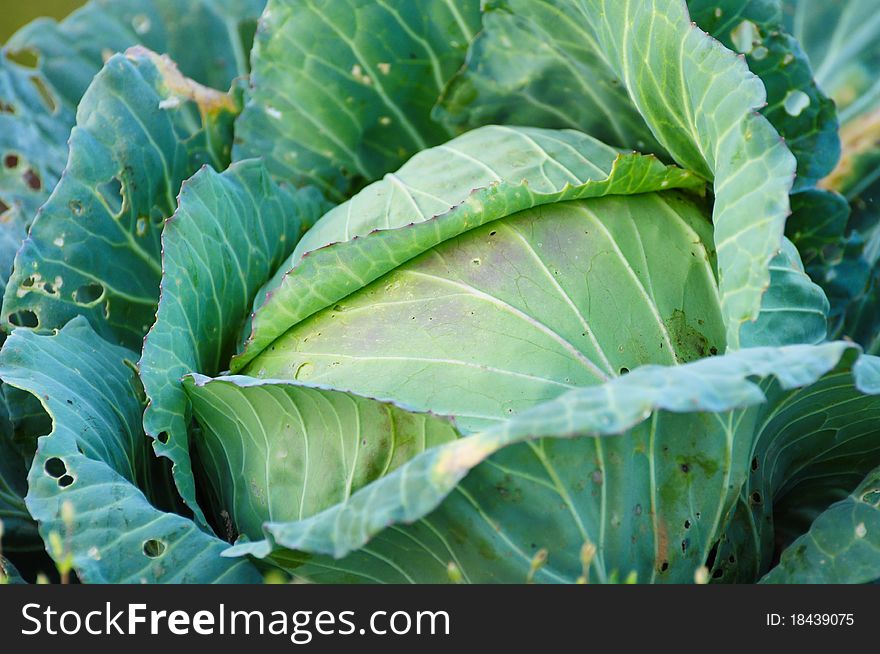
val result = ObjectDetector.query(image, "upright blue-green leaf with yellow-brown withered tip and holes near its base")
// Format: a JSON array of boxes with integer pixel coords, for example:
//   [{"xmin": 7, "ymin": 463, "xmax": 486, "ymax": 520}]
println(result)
[{"xmin": 3, "ymin": 48, "xmax": 236, "ymax": 347}]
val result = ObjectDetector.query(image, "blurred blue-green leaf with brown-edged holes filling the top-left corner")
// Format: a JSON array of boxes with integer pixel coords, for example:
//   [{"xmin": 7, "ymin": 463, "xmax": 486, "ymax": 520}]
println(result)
[{"xmin": 0, "ymin": 0, "xmax": 265, "ymax": 290}]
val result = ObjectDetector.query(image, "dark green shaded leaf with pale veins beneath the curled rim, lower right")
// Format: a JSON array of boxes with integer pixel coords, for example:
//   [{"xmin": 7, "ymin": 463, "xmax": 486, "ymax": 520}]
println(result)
[{"xmin": 711, "ymin": 356, "xmax": 880, "ymax": 582}]
